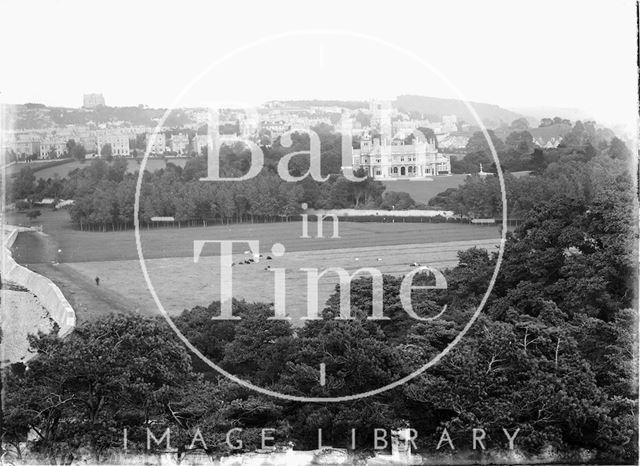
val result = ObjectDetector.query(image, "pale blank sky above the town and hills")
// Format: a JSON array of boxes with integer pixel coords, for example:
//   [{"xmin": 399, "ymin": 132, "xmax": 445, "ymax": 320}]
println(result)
[{"xmin": 0, "ymin": 0, "xmax": 637, "ymax": 131}]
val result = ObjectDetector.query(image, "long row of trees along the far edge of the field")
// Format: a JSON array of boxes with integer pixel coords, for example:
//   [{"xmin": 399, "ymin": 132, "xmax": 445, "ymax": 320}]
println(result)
[{"xmin": 63, "ymin": 159, "xmax": 416, "ymax": 231}]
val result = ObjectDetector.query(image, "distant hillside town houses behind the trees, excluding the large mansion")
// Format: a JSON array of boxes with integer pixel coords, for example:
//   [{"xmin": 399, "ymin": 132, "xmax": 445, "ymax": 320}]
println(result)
[{"xmin": 5, "ymin": 94, "xmax": 469, "ymax": 160}]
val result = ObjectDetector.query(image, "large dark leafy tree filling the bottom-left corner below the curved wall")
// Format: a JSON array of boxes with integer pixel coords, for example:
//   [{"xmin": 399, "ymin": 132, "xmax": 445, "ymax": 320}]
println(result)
[{"xmin": 5, "ymin": 315, "xmax": 194, "ymax": 461}]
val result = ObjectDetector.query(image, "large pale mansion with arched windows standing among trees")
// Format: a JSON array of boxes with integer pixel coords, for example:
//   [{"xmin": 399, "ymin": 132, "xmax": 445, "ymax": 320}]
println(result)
[{"xmin": 352, "ymin": 135, "xmax": 451, "ymax": 179}]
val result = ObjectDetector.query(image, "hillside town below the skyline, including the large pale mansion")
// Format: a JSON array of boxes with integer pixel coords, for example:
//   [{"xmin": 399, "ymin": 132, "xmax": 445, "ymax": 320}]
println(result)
[{"xmin": 3, "ymin": 94, "xmax": 584, "ymax": 185}]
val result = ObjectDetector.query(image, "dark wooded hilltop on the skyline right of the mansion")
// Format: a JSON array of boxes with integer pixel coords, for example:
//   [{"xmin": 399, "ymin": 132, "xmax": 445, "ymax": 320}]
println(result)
[{"xmin": 394, "ymin": 95, "xmax": 522, "ymax": 128}]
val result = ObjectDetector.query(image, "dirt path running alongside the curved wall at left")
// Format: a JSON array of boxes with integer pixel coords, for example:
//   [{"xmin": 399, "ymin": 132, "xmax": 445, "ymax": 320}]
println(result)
[{"xmin": 13, "ymin": 232, "xmax": 152, "ymax": 324}]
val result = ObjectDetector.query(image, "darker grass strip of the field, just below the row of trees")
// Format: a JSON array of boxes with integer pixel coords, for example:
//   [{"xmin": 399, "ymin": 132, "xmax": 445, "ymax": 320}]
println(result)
[{"xmin": 7, "ymin": 210, "xmax": 498, "ymax": 263}]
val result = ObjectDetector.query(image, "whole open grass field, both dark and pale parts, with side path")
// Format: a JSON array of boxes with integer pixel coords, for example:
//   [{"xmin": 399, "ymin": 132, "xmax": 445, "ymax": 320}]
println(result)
[{"xmin": 11, "ymin": 211, "xmax": 498, "ymax": 321}]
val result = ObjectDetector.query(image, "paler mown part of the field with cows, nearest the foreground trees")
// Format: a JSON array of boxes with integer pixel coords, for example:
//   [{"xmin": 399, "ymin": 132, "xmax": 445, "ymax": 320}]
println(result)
[{"xmin": 69, "ymin": 239, "xmax": 498, "ymax": 319}]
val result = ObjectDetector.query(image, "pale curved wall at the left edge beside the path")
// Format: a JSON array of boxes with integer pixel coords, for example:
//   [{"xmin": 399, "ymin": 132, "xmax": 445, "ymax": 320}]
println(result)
[{"xmin": 2, "ymin": 225, "xmax": 76, "ymax": 337}]
